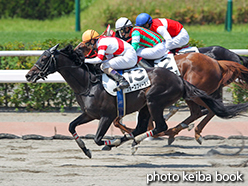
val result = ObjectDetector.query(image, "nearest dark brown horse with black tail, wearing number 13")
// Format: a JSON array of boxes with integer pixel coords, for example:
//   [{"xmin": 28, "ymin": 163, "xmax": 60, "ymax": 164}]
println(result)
[{"xmin": 26, "ymin": 45, "xmax": 248, "ymax": 158}]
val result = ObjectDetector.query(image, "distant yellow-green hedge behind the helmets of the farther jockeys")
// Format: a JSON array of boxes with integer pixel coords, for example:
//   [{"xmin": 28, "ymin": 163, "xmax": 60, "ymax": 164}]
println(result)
[{"xmin": 102, "ymin": 2, "xmax": 248, "ymax": 28}]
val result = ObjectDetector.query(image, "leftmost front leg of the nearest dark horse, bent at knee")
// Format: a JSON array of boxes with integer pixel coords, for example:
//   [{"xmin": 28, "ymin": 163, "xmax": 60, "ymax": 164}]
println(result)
[{"xmin": 69, "ymin": 112, "xmax": 93, "ymax": 158}]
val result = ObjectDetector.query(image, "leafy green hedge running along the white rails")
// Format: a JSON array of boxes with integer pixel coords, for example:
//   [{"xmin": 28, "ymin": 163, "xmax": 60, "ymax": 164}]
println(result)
[{"xmin": 0, "ymin": 39, "xmax": 248, "ymax": 111}]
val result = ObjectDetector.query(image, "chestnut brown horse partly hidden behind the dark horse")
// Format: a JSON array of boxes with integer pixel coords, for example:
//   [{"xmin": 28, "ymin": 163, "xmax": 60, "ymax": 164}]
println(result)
[{"xmin": 81, "ymin": 46, "xmax": 248, "ymax": 144}]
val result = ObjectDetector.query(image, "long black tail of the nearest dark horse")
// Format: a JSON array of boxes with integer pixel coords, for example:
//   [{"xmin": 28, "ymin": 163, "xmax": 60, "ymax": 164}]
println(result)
[{"xmin": 182, "ymin": 78, "xmax": 248, "ymax": 119}]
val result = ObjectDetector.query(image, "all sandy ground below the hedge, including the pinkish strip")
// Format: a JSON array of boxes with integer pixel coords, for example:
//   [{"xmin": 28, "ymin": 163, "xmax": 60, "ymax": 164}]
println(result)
[{"xmin": 0, "ymin": 111, "xmax": 248, "ymax": 186}]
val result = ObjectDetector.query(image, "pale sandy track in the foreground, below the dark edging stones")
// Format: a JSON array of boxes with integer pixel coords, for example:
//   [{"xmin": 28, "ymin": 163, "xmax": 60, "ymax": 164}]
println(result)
[{"xmin": 0, "ymin": 139, "xmax": 248, "ymax": 186}]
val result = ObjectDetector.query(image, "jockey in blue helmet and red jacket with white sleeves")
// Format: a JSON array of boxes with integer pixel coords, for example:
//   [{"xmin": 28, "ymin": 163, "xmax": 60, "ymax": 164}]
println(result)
[{"xmin": 135, "ymin": 13, "xmax": 189, "ymax": 50}]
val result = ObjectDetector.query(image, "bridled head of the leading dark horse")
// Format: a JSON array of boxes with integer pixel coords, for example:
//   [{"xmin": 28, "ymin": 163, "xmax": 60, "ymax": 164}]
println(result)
[{"xmin": 26, "ymin": 44, "xmax": 59, "ymax": 83}]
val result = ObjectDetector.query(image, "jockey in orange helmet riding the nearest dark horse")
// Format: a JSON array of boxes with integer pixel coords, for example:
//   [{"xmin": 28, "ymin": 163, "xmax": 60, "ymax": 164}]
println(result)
[{"xmin": 82, "ymin": 30, "xmax": 137, "ymax": 91}]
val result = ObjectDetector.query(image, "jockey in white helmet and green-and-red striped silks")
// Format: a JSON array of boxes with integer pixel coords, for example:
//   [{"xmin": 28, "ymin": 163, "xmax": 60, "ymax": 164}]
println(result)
[{"xmin": 115, "ymin": 17, "xmax": 166, "ymax": 59}]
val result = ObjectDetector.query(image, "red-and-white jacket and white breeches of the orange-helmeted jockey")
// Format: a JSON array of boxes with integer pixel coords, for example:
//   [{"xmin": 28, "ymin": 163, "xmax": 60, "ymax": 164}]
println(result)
[{"xmin": 85, "ymin": 36, "xmax": 137, "ymax": 70}]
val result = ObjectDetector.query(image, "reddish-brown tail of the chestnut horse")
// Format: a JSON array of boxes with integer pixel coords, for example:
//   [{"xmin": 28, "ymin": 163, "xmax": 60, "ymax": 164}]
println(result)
[{"xmin": 218, "ymin": 60, "xmax": 248, "ymax": 86}]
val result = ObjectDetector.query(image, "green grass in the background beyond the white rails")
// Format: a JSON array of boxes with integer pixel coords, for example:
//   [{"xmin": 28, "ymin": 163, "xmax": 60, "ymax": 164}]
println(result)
[{"xmin": 0, "ymin": 0, "xmax": 248, "ymax": 49}]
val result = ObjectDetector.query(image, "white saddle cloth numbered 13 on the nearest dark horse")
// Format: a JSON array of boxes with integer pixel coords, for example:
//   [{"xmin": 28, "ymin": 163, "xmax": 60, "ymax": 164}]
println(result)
[{"xmin": 102, "ymin": 67, "xmax": 151, "ymax": 96}]
